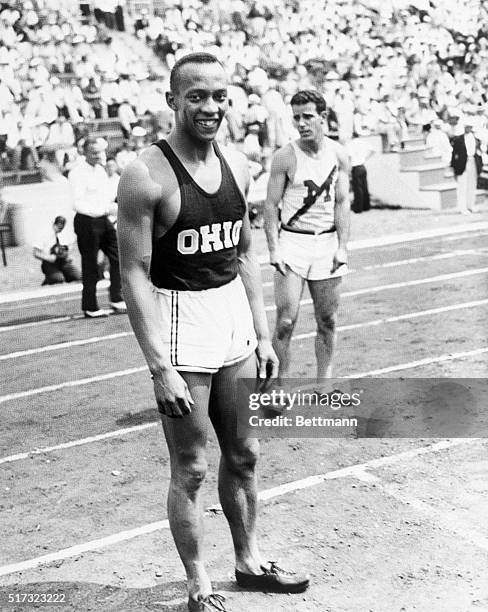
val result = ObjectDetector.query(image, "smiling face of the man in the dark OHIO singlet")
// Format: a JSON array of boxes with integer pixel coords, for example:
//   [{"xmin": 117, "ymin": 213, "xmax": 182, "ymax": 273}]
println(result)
[{"xmin": 167, "ymin": 62, "xmax": 228, "ymax": 142}]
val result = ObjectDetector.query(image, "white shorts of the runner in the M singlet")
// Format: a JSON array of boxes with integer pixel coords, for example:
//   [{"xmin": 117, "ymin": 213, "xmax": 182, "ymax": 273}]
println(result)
[{"xmin": 280, "ymin": 230, "xmax": 347, "ymax": 280}]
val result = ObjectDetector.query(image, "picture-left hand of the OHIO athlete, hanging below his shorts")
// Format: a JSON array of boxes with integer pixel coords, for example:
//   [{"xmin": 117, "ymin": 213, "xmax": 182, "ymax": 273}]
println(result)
[{"xmin": 152, "ymin": 367, "xmax": 194, "ymax": 418}]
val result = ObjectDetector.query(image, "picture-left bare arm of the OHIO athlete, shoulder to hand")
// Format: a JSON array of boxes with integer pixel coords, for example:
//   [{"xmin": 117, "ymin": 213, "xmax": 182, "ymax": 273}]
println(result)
[{"xmin": 117, "ymin": 160, "xmax": 193, "ymax": 417}]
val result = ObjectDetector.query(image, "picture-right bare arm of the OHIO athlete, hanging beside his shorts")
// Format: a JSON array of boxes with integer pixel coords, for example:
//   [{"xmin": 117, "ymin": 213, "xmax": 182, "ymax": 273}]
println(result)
[{"xmin": 237, "ymin": 155, "xmax": 278, "ymax": 379}]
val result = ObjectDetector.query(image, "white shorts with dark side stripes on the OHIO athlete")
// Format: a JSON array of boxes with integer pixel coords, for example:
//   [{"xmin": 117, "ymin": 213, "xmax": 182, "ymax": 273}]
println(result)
[{"xmin": 154, "ymin": 276, "xmax": 257, "ymax": 374}]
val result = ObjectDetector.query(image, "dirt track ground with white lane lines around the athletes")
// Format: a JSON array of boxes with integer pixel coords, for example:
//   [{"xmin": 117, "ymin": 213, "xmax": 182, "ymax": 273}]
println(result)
[{"xmin": 0, "ymin": 216, "xmax": 488, "ymax": 612}]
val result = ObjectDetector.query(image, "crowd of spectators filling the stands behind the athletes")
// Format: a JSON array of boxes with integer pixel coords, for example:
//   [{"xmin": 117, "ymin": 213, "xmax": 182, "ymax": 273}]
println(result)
[{"xmin": 0, "ymin": 0, "xmax": 488, "ymax": 206}]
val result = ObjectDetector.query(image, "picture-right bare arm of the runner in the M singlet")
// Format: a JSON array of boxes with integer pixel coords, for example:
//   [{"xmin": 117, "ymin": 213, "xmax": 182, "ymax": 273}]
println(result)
[{"xmin": 332, "ymin": 146, "xmax": 351, "ymax": 272}]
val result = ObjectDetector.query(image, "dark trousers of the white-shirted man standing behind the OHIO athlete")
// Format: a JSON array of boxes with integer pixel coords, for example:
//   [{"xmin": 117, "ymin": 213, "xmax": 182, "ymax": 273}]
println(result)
[{"xmin": 74, "ymin": 213, "xmax": 122, "ymax": 311}]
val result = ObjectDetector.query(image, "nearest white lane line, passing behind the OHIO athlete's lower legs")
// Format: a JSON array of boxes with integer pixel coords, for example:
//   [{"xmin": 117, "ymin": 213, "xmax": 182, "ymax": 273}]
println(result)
[{"xmin": 0, "ymin": 438, "xmax": 478, "ymax": 576}]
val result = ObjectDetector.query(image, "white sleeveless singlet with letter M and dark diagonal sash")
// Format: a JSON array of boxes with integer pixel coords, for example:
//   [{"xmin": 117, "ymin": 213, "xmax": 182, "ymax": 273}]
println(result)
[{"xmin": 281, "ymin": 142, "xmax": 338, "ymax": 233}]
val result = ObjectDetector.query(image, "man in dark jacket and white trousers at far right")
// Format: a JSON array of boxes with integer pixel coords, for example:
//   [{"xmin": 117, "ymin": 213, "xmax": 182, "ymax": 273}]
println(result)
[{"xmin": 451, "ymin": 117, "xmax": 483, "ymax": 215}]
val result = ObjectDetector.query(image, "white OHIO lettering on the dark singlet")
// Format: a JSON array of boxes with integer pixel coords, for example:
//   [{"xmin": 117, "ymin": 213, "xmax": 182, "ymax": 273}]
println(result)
[{"xmin": 176, "ymin": 219, "xmax": 242, "ymax": 255}]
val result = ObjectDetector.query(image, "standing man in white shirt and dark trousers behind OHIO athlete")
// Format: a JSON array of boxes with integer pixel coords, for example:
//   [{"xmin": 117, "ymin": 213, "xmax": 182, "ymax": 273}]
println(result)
[{"xmin": 68, "ymin": 137, "xmax": 126, "ymax": 318}]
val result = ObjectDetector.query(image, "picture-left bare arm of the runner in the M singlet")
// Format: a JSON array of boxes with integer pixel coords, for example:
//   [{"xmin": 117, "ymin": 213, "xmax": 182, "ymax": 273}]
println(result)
[{"xmin": 264, "ymin": 149, "xmax": 288, "ymax": 274}]
